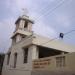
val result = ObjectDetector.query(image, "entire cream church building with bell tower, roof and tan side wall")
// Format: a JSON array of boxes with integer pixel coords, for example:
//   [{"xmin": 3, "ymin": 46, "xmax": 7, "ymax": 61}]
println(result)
[{"xmin": 2, "ymin": 15, "xmax": 75, "ymax": 75}]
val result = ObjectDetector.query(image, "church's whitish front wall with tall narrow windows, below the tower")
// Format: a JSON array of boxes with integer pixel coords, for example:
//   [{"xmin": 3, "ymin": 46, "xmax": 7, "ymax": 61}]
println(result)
[{"xmin": 2, "ymin": 39, "xmax": 34, "ymax": 75}]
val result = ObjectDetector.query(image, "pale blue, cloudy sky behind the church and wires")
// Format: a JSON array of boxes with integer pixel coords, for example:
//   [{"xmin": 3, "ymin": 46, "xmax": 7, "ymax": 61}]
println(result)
[{"xmin": 0, "ymin": 0, "xmax": 75, "ymax": 52}]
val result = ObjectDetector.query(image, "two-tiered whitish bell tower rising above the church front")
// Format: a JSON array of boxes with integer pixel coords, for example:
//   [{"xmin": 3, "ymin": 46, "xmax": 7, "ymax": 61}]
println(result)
[{"xmin": 12, "ymin": 12, "xmax": 34, "ymax": 45}]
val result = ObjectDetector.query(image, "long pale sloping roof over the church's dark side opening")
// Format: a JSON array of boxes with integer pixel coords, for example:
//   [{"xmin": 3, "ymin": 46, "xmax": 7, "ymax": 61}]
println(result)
[{"xmin": 33, "ymin": 34, "xmax": 75, "ymax": 52}]
